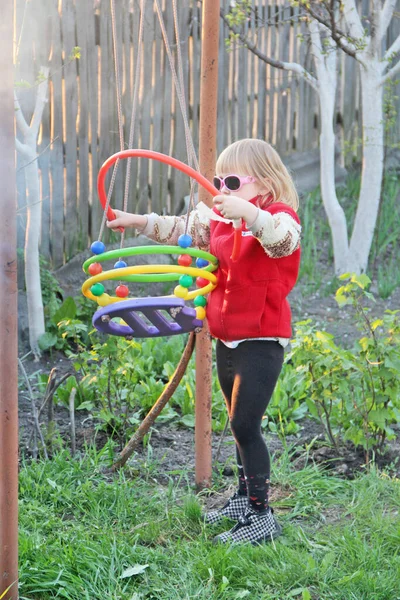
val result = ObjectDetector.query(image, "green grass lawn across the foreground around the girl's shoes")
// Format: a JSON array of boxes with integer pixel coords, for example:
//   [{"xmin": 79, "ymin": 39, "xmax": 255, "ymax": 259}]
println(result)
[{"xmin": 20, "ymin": 442, "xmax": 400, "ymax": 600}]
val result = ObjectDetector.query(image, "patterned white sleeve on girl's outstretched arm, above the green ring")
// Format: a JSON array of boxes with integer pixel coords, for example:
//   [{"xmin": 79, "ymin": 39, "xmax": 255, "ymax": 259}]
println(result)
[{"xmin": 139, "ymin": 210, "xmax": 210, "ymax": 250}]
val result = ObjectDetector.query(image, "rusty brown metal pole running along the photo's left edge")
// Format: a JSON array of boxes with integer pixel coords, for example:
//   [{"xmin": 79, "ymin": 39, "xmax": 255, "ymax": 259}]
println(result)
[{"xmin": 0, "ymin": 0, "xmax": 18, "ymax": 600}]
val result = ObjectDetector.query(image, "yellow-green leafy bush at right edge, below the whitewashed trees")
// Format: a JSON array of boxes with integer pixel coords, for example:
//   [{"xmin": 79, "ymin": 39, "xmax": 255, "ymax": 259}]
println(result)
[{"xmin": 290, "ymin": 274, "xmax": 400, "ymax": 463}]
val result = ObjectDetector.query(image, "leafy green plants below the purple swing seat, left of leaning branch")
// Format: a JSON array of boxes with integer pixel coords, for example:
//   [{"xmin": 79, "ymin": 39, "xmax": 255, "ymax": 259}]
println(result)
[{"xmin": 63, "ymin": 336, "xmax": 195, "ymax": 444}]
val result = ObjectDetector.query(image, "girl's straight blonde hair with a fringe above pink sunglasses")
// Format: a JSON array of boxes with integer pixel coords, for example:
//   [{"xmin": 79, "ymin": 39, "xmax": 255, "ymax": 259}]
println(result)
[{"xmin": 216, "ymin": 138, "xmax": 299, "ymax": 211}]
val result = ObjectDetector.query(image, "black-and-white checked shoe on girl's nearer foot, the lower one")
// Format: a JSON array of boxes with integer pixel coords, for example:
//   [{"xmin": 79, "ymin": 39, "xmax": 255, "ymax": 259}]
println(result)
[{"xmin": 213, "ymin": 506, "xmax": 282, "ymax": 544}]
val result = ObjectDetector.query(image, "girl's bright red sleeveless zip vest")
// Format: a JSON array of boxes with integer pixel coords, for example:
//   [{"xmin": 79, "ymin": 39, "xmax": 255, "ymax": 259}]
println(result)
[{"xmin": 207, "ymin": 199, "xmax": 300, "ymax": 342}]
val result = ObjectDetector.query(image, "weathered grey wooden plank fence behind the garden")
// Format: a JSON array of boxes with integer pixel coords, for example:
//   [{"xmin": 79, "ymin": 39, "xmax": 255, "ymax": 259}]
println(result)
[{"xmin": 15, "ymin": 0, "xmax": 399, "ymax": 268}]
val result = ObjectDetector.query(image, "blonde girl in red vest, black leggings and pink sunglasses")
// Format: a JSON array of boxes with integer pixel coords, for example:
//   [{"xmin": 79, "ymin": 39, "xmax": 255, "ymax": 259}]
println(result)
[{"xmin": 107, "ymin": 139, "xmax": 301, "ymax": 544}]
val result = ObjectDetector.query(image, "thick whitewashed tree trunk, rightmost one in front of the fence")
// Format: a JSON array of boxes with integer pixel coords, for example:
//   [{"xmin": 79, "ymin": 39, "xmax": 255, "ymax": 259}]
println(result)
[{"xmin": 350, "ymin": 57, "xmax": 384, "ymax": 273}]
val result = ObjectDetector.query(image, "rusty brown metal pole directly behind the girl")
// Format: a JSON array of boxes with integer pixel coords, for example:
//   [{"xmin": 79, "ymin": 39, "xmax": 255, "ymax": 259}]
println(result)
[{"xmin": 195, "ymin": 0, "xmax": 220, "ymax": 489}]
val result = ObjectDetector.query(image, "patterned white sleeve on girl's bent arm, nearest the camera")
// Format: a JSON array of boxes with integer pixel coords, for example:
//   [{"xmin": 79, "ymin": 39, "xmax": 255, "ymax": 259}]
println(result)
[{"xmin": 248, "ymin": 209, "xmax": 301, "ymax": 258}]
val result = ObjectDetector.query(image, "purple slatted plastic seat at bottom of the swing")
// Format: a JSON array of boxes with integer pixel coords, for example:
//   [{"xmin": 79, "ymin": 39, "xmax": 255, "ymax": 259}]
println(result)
[{"xmin": 92, "ymin": 297, "xmax": 203, "ymax": 338}]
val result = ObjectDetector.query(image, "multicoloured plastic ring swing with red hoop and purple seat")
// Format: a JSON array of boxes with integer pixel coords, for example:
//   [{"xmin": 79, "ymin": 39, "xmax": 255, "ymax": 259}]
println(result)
[{"xmin": 82, "ymin": 150, "xmax": 241, "ymax": 338}]
